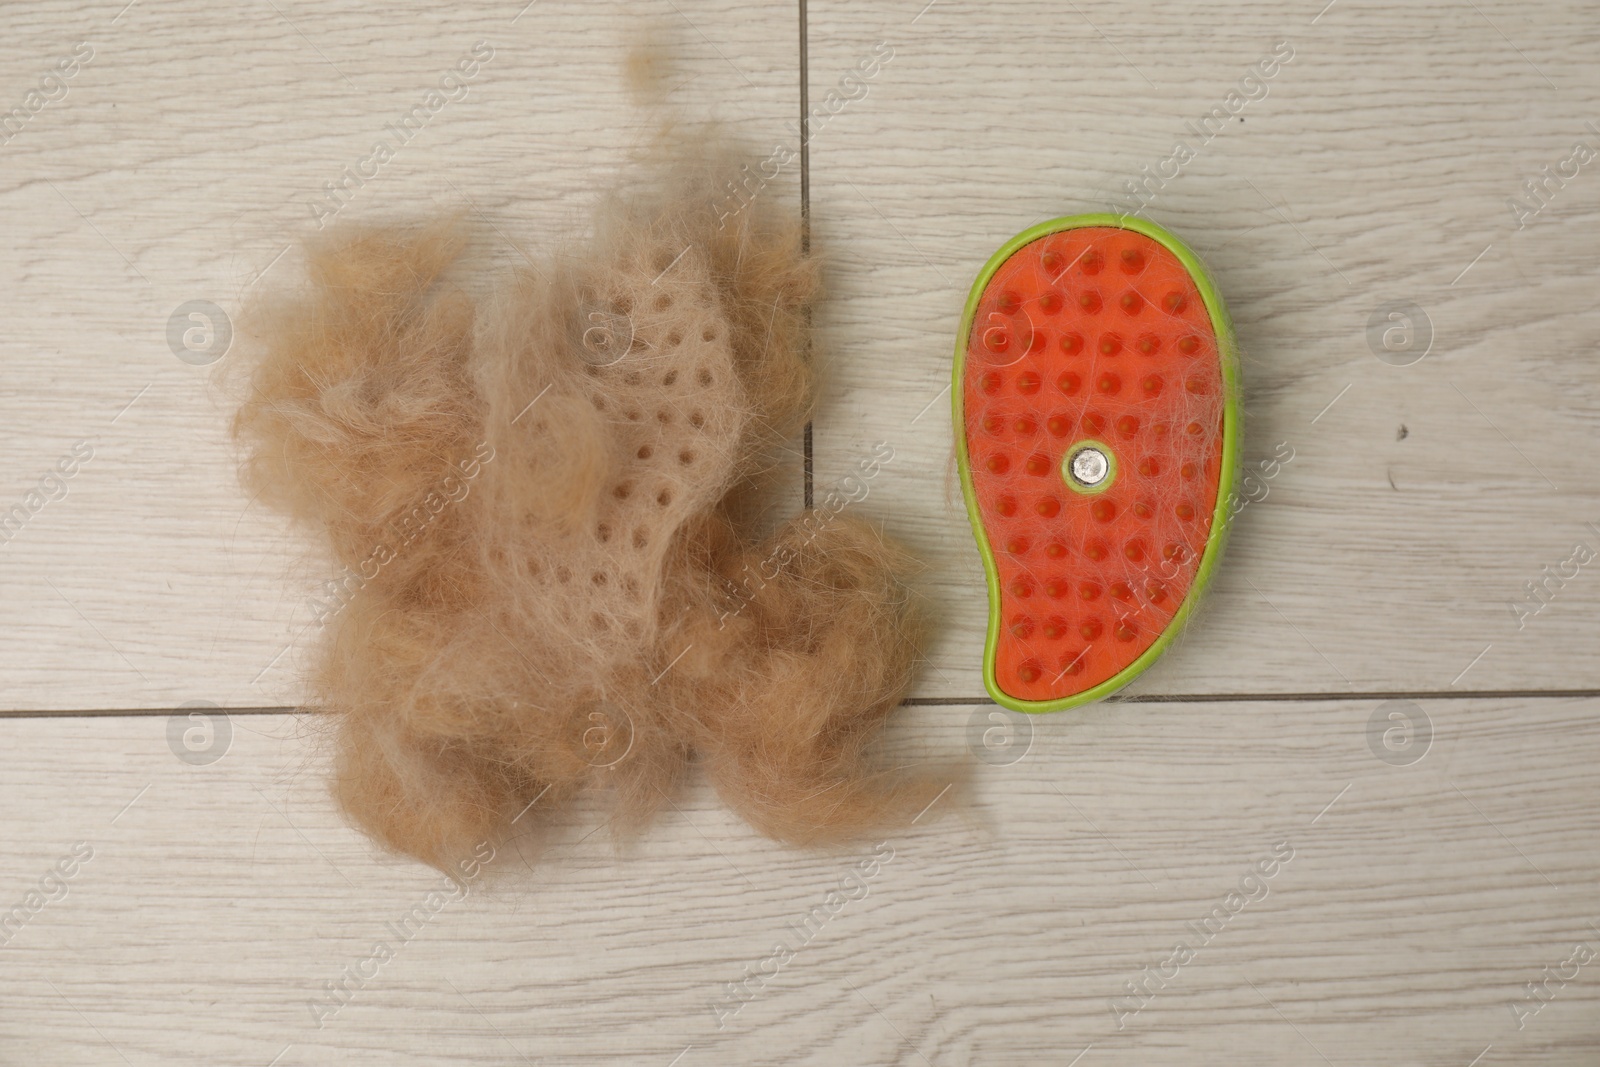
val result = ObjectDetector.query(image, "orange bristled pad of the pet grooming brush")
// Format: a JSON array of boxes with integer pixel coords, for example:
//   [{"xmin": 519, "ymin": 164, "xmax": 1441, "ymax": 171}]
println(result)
[{"xmin": 963, "ymin": 227, "xmax": 1226, "ymax": 701}]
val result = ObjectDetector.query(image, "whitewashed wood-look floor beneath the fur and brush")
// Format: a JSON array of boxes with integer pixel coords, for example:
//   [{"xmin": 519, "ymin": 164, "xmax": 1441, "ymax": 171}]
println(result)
[{"xmin": 0, "ymin": 0, "xmax": 1600, "ymax": 1067}]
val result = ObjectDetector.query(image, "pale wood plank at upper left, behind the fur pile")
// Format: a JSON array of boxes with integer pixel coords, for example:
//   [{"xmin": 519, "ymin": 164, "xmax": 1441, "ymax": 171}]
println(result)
[{"xmin": 0, "ymin": 0, "xmax": 798, "ymax": 709}]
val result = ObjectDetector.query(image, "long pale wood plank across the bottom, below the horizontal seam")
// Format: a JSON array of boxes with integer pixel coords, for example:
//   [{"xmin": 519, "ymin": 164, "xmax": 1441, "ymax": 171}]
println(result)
[{"xmin": 0, "ymin": 699, "xmax": 1600, "ymax": 1067}]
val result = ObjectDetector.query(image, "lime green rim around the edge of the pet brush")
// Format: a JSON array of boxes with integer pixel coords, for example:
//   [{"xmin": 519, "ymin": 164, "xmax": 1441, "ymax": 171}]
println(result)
[{"xmin": 950, "ymin": 213, "xmax": 1238, "ymax": 715}]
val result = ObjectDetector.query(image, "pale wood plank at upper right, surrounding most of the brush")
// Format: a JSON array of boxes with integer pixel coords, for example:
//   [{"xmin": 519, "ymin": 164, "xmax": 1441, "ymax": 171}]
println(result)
[{"xmin": 810, "ymin": 0, "xmax": 1600, "ymax": 696}]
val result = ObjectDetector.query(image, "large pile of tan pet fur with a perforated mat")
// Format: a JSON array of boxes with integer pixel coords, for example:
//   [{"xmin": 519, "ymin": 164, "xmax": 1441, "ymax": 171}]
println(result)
[{"xmin": 234, "ymin": 135, "xmax": 947, "ymax": 867}]
